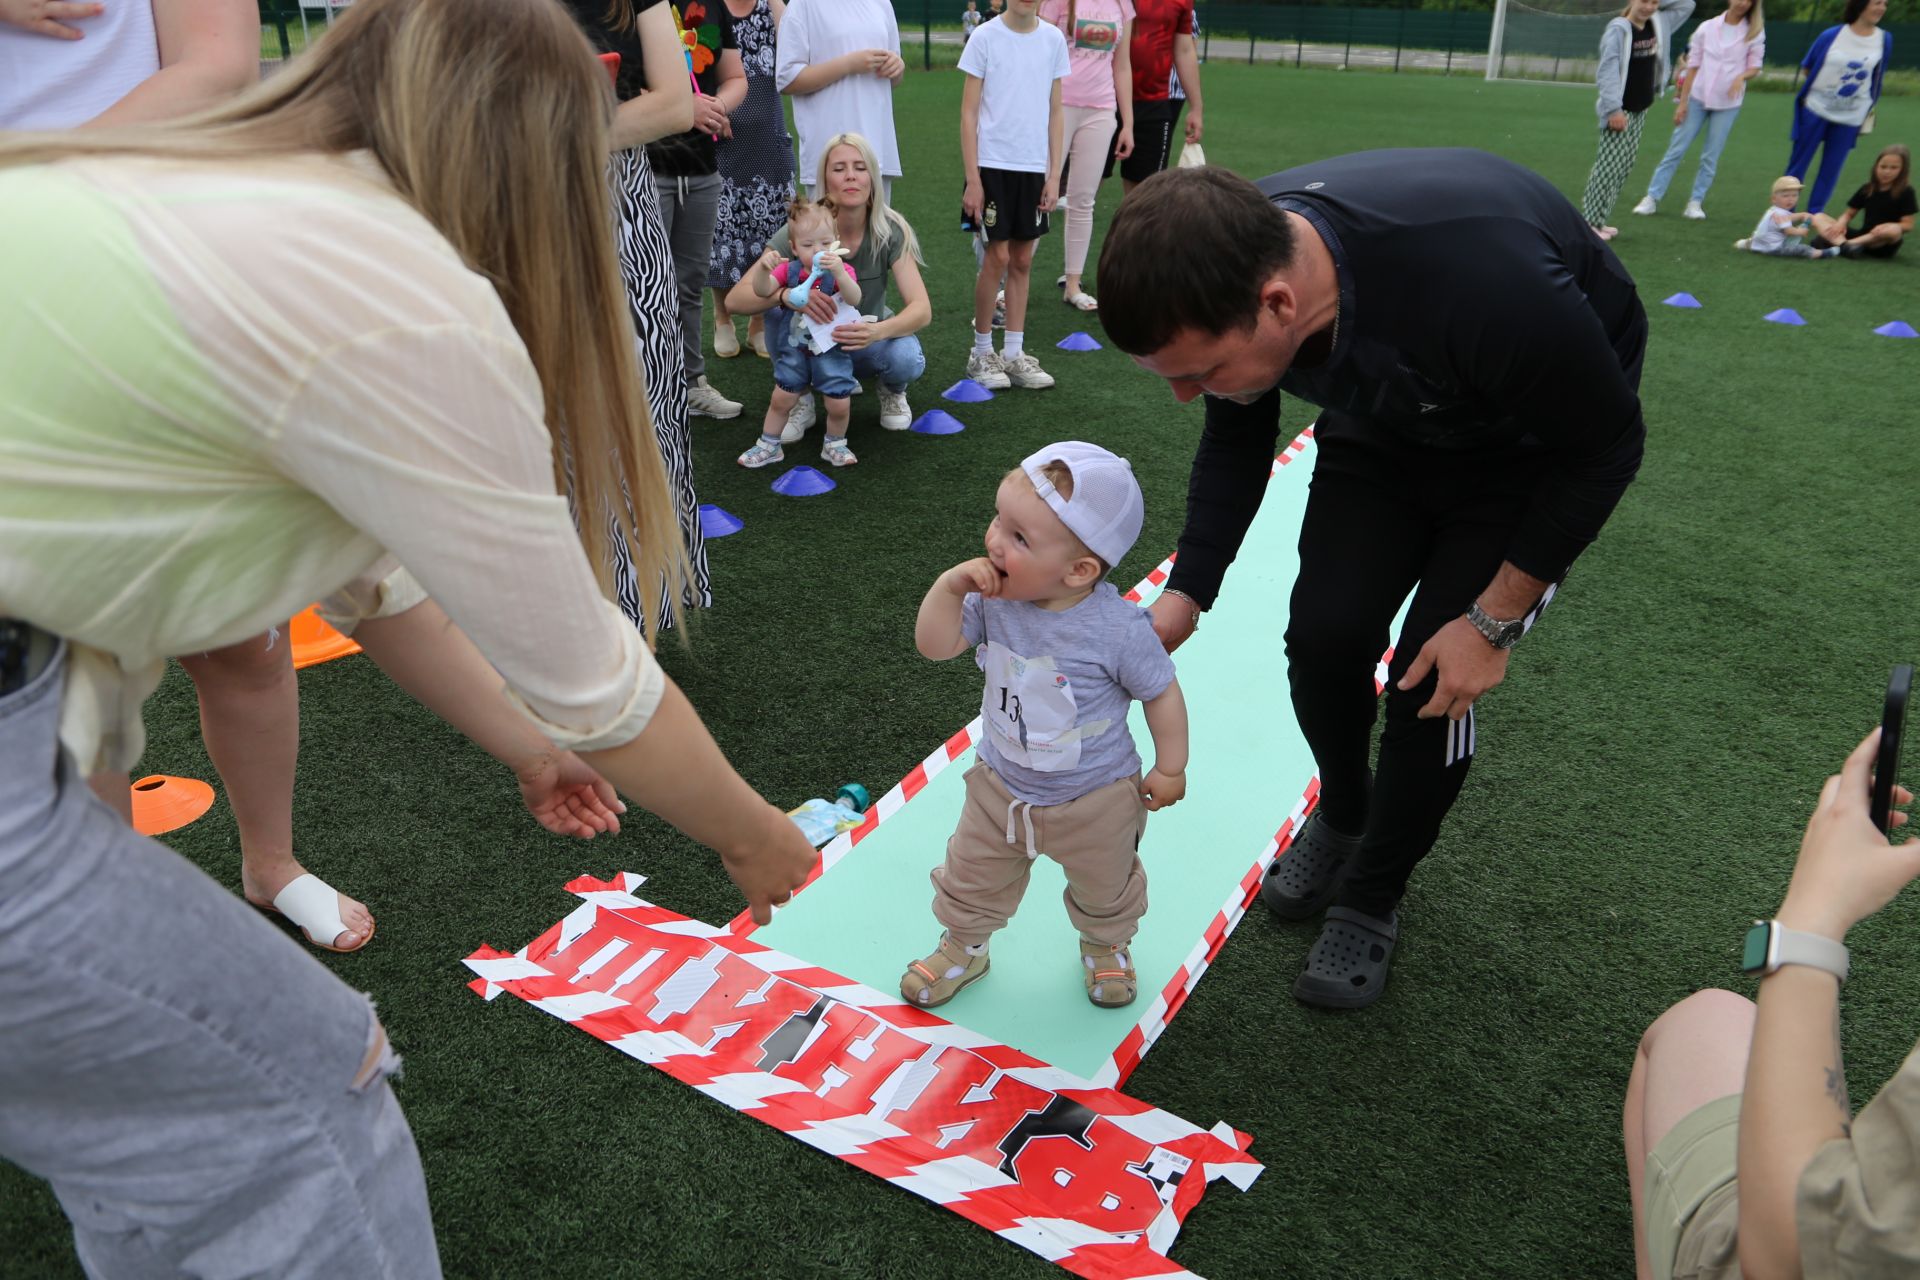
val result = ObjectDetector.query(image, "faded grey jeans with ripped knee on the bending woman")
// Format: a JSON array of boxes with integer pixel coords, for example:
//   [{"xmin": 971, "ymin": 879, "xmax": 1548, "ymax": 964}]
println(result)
[{"xmin": 0, "ymin": 649, "xmax": 440, "ymax": 1280}]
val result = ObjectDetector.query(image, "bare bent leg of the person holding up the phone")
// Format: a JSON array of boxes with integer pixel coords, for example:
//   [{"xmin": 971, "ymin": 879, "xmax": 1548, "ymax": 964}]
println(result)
[{"xmin": 1620, "ymin": 990, "xmax": 1755, "ymax": 1280}]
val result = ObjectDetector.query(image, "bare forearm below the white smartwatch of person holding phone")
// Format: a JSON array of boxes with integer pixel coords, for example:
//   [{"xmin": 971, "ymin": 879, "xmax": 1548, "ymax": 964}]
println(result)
[{"xmin": 1740, "ymin": 967, "xmax": 1853, "ymax": 1280}]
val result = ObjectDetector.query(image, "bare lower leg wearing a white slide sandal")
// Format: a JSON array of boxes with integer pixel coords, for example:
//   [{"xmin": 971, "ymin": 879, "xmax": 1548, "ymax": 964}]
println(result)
[{"xmin": 180, "ymin": 628, "xmax": 372, "ymax": 948}]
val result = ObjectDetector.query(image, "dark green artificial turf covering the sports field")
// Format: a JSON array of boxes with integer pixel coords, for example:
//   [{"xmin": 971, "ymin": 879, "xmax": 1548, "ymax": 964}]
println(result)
[{"xmin": 0, "ymin": 63, "xmax": 1920, "ymax": 1280}]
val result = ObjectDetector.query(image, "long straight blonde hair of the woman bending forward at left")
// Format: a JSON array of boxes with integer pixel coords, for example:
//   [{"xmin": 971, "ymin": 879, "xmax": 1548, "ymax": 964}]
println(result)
[{"xmin": 0, "ymin": 0, "xmax": 693, "ymax": 643}]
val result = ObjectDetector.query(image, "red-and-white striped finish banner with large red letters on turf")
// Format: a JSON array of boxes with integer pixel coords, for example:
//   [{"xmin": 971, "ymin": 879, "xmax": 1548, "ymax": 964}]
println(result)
[{"xmin": 467, "ymin": 873, "xmax": 1261, "ymax": 1280}]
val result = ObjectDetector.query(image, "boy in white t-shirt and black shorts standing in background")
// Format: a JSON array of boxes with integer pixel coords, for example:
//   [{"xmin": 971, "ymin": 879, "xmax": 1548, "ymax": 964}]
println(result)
[{"xmin": 960, "ymin": 0, "xmax": 1071, "ymax": 390}]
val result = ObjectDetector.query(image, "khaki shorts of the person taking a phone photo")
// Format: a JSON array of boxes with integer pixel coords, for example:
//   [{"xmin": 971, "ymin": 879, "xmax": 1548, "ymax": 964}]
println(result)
[{"xmin": 1645, "ymin": 1094, "xmax": 1740, "ymax": 1280}]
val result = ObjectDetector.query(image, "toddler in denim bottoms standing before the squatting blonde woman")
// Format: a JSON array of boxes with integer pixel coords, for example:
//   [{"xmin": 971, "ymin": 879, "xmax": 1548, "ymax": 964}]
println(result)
[{"xmin": 739, "ymin": 196, "xmax": 860, "ymax": 466}]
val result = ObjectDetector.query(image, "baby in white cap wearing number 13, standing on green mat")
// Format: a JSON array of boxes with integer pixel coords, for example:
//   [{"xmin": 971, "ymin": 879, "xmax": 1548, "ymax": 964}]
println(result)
[{"xmin": 900, "ymin": 441, "xmax": 1187, "ymax": 1007}]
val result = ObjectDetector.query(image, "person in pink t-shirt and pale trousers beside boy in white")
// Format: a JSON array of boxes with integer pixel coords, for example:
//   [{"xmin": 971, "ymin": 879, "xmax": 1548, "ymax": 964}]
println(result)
[{"xmin": 1041, "ymin": 0, "xmax": 1133, "ymax": 311}]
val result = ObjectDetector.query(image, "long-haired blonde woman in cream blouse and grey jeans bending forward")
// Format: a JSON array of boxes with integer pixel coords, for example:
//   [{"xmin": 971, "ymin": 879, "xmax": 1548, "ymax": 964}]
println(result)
[{"xmin": 0, "ymin": 0, "xmax": 812, "ymax": 1278}]
